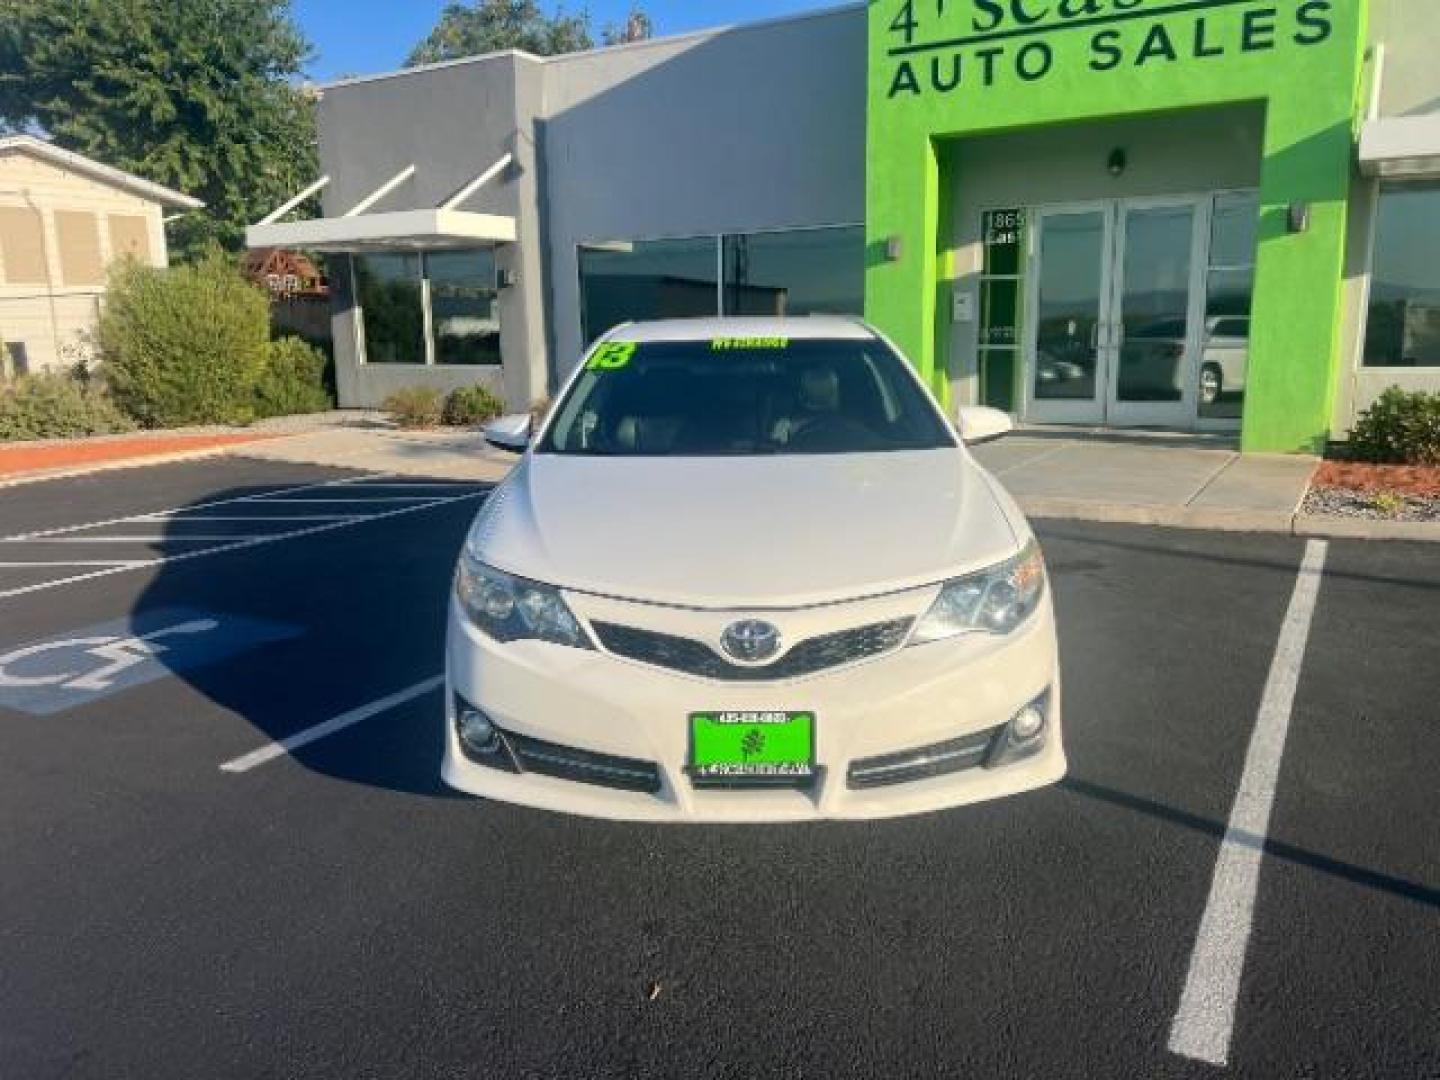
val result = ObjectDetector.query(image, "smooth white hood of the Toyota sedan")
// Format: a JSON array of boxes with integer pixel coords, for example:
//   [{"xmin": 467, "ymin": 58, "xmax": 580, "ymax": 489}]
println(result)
[{"xmin": 469, "ymin": 449, "xmax": 1020, "ymax": 608}]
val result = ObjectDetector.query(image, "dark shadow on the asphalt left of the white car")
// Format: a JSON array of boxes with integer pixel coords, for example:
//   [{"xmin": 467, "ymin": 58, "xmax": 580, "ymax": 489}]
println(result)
[{"xmin": 131, "ymin": 478, "xmax": 490, "ymax": 798}]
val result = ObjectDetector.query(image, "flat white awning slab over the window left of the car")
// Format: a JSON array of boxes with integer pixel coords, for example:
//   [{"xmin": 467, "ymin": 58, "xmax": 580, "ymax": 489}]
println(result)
[{"xmin": 245, "ymin": 209, "xmax": 516, "ymax": 252}]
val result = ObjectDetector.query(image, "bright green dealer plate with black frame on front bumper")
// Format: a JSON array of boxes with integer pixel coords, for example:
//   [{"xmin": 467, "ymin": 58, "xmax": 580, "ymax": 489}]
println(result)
[{"xmin": 690, "ymin": 713, "xmax": 815, "ymax": 783}]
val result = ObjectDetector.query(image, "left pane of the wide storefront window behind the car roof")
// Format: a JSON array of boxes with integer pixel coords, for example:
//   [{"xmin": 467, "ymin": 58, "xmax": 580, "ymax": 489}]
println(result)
[{"xmin": 580, "ymin": 236, "xmax": 720, "ymax": 341}]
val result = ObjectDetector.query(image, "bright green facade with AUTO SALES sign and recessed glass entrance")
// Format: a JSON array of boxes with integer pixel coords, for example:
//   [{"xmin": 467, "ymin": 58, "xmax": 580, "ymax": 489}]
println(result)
[{"xmin": 865, "ymin": 0, "xmax": 1369, "ymax": 452}]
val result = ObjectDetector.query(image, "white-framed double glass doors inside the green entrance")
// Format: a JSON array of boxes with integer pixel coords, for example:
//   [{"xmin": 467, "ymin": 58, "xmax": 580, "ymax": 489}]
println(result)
[{"xmin": 1025, "ymin": 199, "xmax": 1208, "ymax": 428}]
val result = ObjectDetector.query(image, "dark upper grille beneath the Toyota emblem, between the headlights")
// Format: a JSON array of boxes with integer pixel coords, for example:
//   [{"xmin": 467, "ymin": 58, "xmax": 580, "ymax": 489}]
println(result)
[{"xmin": 592, "ymin": 618, "xmax": 914, "ymax": 683}]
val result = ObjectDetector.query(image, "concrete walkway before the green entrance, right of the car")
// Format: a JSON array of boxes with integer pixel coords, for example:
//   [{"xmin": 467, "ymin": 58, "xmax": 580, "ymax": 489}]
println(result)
[{"xmin": 975, "ymin": 431, "xmax": 1319, "ymax": 531}]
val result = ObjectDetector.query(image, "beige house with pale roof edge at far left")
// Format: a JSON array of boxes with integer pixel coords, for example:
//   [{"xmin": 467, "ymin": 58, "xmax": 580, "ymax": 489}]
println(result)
[{"xmin": 0, "ymin": 135, "xmax": 203, "ymax": 372}]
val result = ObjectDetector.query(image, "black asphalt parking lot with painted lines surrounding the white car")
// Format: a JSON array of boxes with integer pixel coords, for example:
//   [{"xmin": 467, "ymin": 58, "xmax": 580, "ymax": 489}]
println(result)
[{"xmin": 0, "ymin": 458, "xmax": 1440, "ymax": 1080}]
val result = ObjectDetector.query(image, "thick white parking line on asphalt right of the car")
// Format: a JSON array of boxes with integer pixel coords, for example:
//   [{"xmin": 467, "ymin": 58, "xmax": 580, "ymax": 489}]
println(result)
[{"xmin": 1169, "ymin": 540, "xmax": 1329, "ymax": 1066}]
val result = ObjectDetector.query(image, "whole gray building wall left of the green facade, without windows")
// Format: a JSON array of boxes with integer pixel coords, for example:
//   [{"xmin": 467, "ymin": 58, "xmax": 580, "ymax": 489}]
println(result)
[{"xmin": 309, "ymin": 4, "xmax": 865, "ymax": 409}]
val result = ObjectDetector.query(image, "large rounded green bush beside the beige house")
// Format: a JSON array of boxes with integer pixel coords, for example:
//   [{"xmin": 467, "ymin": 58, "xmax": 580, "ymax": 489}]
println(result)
[{"xmin": 96, "ymin": 255, "xmax": 269, "ymax": 428}]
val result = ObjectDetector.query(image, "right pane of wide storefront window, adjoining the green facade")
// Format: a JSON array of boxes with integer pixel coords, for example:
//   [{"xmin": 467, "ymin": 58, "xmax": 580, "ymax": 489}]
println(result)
[{"xmin": 723, "ymin": 226, "xmax": 865, "ymax": 315}]
